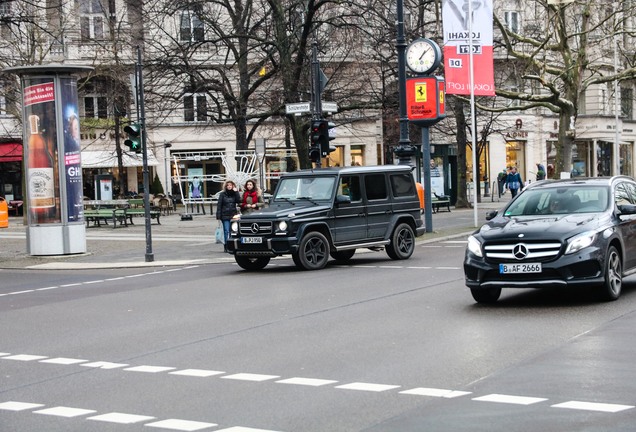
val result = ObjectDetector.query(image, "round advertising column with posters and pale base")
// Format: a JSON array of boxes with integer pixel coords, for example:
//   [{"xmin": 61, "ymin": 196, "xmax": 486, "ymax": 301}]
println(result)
[{"xmin": 4, "ymin": 65, "xmax": 92, "ymax": 255}]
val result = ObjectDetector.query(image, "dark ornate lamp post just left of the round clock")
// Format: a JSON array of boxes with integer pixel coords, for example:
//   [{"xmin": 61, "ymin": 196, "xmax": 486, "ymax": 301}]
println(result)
[{"xmin": 394, "ymin": 0, "xmax": 415, "ymax": 165}]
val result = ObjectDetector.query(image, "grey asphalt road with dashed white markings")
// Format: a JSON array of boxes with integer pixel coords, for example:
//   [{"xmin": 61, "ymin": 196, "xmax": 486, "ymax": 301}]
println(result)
[{"xmin": 0, "ymin": 239, "xmax": 636, "ymax": 432}]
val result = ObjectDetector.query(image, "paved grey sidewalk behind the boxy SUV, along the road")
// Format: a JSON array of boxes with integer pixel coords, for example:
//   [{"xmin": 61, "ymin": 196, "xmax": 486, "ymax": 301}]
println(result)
[{"xmin": 0, "ymin": 194, "xmax": 510, "ymax": 270}]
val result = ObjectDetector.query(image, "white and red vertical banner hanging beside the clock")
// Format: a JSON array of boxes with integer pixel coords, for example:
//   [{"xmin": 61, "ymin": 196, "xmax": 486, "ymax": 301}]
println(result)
[{"xmin": 442, "ymin": 0, "xmax": 495, "ymax": 96}]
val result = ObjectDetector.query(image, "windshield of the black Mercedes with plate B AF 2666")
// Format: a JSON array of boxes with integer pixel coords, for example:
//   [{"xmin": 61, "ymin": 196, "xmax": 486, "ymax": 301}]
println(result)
[{"xmin": 504, "ymin": 186, "xmax": 609, "ymax": 216}]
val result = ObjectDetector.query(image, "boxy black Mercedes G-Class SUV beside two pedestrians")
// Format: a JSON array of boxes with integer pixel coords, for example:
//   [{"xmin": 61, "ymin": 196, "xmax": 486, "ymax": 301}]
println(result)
[{"xmin": 227, "ymin": 165, "xmax": 425, "ymax": 270}]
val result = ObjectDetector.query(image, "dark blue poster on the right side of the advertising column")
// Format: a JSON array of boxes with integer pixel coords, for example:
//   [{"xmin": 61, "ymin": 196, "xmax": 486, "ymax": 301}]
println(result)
[{"xmin": 60, "ymin": 78, "xmax": 84, "ymax": 222}]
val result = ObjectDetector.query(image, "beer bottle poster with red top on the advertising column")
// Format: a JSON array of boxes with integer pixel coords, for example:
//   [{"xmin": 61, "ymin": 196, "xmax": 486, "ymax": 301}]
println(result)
[{"xmin": 24, "ymin": 78, "xmax": 61, "ymax": 225}]
